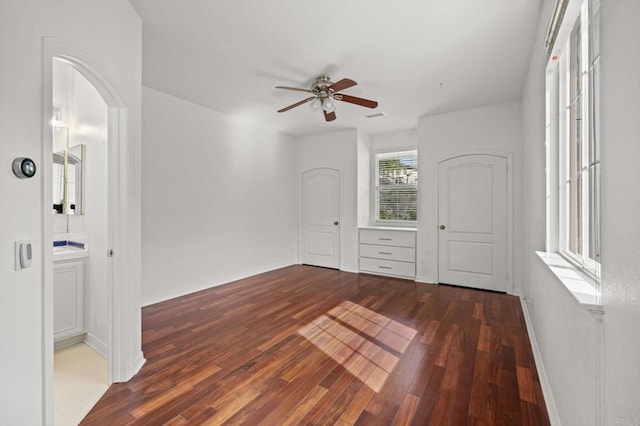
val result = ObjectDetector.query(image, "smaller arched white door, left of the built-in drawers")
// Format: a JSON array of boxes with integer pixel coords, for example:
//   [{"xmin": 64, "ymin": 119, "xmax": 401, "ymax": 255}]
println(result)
[{"xmin": 301, "ymin": 169, "xmax": 340, "ymax": 269}]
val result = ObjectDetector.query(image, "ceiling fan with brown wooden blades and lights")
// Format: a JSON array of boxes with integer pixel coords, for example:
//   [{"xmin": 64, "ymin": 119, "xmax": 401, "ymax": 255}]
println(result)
[{"xmin": 276, "ymin": 75, "xmax": 378, "ymax": 121}]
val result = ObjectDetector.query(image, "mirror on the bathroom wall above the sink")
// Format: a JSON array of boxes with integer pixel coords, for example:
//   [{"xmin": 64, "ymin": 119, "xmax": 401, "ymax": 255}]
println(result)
[{"xmin": 53, "ymin": 127, "xmax": 86, "ymax": 215}]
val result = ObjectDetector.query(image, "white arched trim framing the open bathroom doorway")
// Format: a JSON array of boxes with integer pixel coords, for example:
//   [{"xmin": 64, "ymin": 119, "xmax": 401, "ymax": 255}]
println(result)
[{"xmin": 40, "ymin": 37, "xmax": 145, "ymax": 424}]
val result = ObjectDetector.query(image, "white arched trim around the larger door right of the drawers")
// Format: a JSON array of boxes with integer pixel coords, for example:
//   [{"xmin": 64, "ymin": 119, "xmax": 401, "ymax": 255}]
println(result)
[{"xmin": 435, "ymin": 149, "xmax": 515, "ymax": 294}]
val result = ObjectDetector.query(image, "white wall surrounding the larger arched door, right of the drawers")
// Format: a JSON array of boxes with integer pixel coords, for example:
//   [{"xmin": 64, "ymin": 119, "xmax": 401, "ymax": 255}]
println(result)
[{"xmin": 416, "ymin": 102, "xmax": 522, "ymax": 288}]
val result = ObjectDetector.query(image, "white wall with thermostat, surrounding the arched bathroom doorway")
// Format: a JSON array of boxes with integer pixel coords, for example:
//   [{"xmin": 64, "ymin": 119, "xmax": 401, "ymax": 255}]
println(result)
[{"xmin": 0, "ymin": 0, "xmax": 141, "ymax": 425}]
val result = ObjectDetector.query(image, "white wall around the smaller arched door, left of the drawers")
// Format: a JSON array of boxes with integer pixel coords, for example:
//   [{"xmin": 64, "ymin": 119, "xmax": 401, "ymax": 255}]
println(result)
[{"xmin": 296, "ymin": 129, "xmax": 358, "ymax": 272}]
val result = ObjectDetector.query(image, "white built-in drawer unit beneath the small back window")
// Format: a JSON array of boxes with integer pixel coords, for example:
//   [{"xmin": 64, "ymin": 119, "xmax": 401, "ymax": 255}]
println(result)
[{"xmin": 358, "ymin": 228, "xmax": 416, "ymax": 279}]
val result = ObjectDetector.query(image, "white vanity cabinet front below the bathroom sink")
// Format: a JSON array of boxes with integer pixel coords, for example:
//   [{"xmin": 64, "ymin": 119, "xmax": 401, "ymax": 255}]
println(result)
[{"xmin": 53, "ymin": 259, "xmax": 85, "ymax": 342}]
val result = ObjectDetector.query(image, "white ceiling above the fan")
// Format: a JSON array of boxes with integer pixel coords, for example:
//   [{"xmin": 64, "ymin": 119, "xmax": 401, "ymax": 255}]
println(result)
[{"xmin": 130, "ymin": 0, "xmax": 541, "ymax": 135}]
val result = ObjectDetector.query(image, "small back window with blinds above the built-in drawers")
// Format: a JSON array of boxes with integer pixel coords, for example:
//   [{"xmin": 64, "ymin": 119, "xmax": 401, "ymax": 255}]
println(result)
[{"xmin": 375, "ymin": 150, "xmax": 418, "ymax": 222}]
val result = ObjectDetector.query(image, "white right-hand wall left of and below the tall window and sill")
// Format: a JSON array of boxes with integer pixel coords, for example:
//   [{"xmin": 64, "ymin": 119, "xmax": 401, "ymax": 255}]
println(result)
[{"xmin": 522, "ymin": 0, "xmax": 598, "ymax": 425}]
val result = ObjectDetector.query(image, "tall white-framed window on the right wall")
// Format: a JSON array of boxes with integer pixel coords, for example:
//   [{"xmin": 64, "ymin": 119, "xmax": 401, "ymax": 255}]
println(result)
[{"xmin": 547, "ymin": 0, "xmax": 600, "ymax": 275}]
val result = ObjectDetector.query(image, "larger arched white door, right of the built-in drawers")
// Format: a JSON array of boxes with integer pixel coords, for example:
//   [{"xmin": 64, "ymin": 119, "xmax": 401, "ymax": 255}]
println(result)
[{"xmin": 438, "ymin": 155, "xmax": 508, "ymax": 292}]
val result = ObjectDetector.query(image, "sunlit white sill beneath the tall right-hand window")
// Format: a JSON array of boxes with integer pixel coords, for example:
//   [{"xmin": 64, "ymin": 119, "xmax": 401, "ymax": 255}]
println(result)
[{"xmin": 536, "ymin": 251, "xmax": 603, "ymax": 315}]
